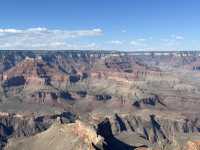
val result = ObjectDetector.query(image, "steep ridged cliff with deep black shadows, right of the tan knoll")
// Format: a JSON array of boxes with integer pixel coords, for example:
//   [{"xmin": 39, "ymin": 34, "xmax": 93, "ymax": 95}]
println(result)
[{"xmin": 91, "ymin": 114, "xmax": 200, "ymax": 150}]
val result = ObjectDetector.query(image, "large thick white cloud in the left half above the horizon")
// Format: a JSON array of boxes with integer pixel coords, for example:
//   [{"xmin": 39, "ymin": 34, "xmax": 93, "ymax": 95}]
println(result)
[{"xmin": 0, "ymin": 27, "xmax": 103, "ymax": 49}]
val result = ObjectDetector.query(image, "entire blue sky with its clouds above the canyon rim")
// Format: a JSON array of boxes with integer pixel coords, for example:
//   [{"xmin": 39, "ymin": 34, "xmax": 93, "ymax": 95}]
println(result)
[{"xmin": 0, "ymin": 0, "xmax": 200, "ymax": 51}]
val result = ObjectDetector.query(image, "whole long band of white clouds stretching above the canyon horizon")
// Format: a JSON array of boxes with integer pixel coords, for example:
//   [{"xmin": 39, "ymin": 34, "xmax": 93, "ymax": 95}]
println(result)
[{"xmin": 0, "ymin": 27, "xmax": 189, "ymax": 51}]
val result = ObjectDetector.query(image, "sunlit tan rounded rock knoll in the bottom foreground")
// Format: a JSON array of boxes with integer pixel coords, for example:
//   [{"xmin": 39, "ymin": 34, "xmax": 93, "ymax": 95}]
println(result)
[{"xmin": 6, "ymin": 121, "xmax": 103, "ymax": 150}]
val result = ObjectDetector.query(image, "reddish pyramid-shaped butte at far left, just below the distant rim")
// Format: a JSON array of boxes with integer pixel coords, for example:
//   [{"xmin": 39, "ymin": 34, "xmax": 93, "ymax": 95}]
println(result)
[{"xmin": 3, "ymin": 58, "xmax": 68, "ymax": 86}]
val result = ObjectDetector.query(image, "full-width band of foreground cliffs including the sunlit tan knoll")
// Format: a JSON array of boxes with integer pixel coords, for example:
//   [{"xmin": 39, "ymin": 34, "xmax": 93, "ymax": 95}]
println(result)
[{"xmin": 0, "ymin": 111, "xmax": 200, "ymax": 150}]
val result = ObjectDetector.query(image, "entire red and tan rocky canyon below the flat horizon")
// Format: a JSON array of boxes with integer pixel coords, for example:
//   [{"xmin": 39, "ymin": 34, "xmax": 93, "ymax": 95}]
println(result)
[{"xmin": 0, "ymin": 50, "xmax": 200, "ymax": 150}]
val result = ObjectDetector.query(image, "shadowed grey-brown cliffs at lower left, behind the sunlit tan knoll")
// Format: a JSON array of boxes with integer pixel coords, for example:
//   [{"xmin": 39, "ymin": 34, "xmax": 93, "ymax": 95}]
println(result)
[{"xmin": 0, "ymin": 112, "xmax": 77, "ymax": 148}]
